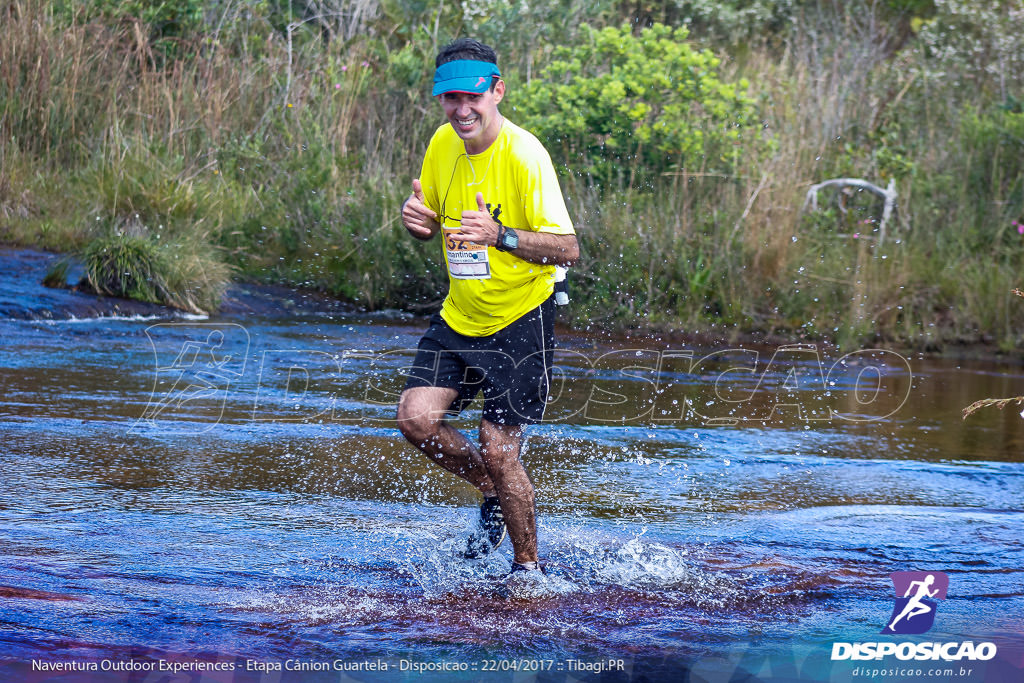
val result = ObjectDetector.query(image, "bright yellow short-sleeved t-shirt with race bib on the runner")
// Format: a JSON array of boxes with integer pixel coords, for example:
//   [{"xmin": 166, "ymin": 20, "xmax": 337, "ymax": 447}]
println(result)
[{"xmin": 420, "ymin": 120, "xmax": 574, "ymax": 337}]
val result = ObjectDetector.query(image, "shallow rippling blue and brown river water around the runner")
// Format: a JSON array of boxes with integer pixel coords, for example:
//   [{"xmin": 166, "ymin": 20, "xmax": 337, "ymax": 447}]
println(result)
[{"xmin": 0, "ymin": 250, "xmax": 1024, "ymax": 682}]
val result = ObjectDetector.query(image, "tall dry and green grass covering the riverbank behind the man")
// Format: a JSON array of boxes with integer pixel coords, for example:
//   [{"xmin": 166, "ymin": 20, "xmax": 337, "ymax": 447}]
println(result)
[{"xmin": 0, "ymin": 0, "xmax": 1024, "ymax": 347}]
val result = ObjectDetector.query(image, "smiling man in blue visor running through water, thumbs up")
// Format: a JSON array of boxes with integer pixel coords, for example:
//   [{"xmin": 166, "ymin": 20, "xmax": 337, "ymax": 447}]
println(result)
[{"xmin": 398, "ymin": 38, "xmax": 580, "ymax": 573}]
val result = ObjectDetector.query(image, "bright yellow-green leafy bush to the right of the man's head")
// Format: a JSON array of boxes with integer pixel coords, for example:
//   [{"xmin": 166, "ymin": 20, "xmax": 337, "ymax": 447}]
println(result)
[{"xmin": 511, "ymin": 25, "xmax": 759, "ymax": 187}]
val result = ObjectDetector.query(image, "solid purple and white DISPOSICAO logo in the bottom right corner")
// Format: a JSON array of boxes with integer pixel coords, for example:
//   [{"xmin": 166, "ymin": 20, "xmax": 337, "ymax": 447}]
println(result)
[{"xmin": 831, "ymin": 571, "xmax": 996, "ymax": 661}]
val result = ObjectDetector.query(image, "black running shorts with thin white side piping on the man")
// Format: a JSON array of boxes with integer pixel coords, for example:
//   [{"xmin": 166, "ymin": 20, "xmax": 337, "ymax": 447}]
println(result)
[{"xmin": 406, "ymin": 299, "xmax": 555, "ymax": 425}]
